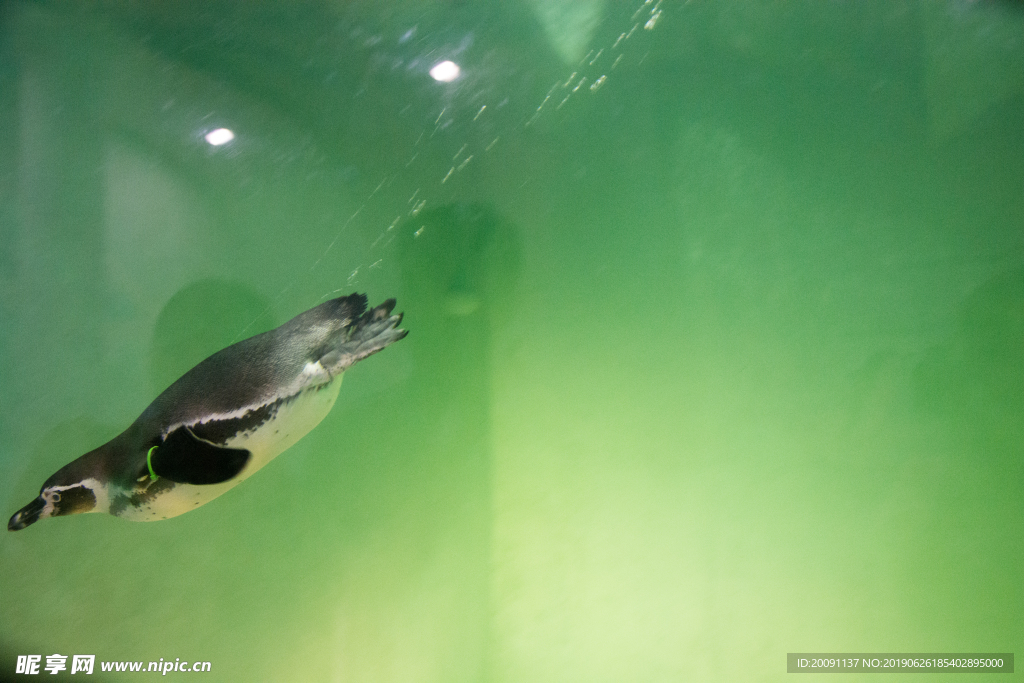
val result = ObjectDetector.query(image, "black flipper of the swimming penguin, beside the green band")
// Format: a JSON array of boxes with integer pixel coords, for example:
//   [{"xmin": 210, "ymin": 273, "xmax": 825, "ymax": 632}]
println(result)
[{"xmin": 150, "ymin": 426, "xmax": 252, "ymax": 485}]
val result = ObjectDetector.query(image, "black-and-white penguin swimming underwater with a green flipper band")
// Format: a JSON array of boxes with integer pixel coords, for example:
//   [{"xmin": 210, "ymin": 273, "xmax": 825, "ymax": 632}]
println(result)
[{"xmin": 7, "ymin": 294, "xmax": 408, "ymax": 531}]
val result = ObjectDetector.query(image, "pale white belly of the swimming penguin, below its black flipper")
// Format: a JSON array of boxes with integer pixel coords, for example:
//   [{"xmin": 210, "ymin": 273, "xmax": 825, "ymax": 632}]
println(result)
[{"xmin": 118, "ymin": 374, "xmax": 342, "ymax": 521}]
